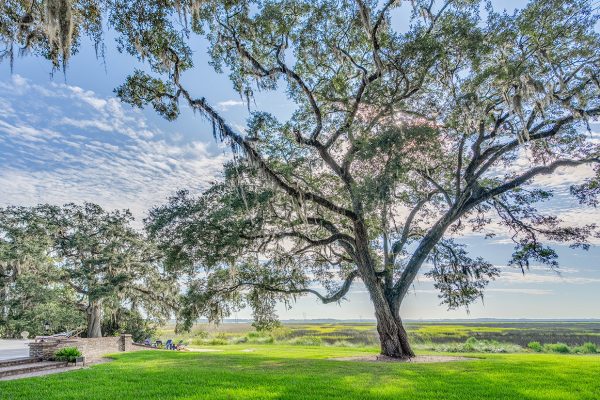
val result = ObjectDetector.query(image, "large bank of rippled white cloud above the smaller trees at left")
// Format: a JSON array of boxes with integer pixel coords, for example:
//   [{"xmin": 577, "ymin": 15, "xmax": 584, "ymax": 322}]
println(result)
[{"xmin": 0, "ymin": 75, "xmax": 228, "ymax": 222}]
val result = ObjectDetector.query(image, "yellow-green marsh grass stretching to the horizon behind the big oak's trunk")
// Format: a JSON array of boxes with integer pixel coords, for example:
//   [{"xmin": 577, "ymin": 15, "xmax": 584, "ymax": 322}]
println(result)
[{"xmin": 160, "ymin": 322, "xmax": 600, "ymax": 354}]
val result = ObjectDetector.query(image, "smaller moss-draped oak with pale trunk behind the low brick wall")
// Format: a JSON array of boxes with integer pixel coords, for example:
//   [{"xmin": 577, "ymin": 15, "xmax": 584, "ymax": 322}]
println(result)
[{"xmin": 0, "ymin": 203, "xmax": 177, "ymax": 337}]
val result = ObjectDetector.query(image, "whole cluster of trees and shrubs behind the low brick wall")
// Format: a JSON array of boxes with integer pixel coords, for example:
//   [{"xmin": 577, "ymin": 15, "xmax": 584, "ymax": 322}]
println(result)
[{"xmin": 0, "ymin": 203, "xmax": 178, "ymax": 340}]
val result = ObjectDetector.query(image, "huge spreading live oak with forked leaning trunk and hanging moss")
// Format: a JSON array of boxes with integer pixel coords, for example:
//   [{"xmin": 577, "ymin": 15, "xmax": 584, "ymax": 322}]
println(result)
[{"xmin": 1, "ymin": 0, "xmax": 600, "ymax": 357}]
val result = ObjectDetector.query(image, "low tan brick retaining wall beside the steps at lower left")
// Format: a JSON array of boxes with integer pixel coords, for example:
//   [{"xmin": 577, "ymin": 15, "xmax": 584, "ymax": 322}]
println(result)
[{"xmin": 29, "ymin": 334, "xmax": 153, "ymax": 360}]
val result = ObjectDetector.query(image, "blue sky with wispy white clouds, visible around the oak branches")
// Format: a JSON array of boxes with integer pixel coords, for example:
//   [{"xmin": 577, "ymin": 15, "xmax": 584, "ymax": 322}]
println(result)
[{"xmin": 0, "ymin": 1, "xmax": 600, "ymax": 319}]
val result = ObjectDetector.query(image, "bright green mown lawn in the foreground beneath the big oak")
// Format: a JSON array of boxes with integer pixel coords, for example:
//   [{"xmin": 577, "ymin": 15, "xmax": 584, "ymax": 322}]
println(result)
[{"xmin": 0, "ymin": 345, "xmax": 600, "ymax": 400}]
